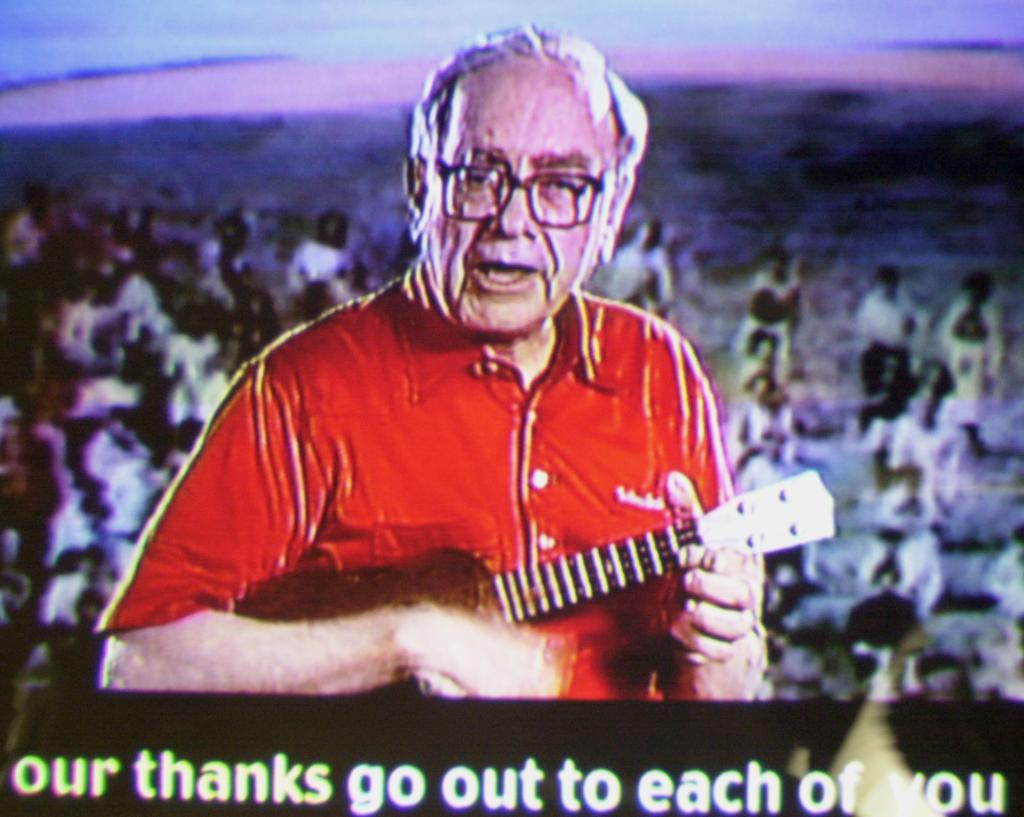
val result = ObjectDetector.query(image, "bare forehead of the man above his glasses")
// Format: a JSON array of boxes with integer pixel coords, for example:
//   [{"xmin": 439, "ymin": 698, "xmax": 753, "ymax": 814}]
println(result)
[{"xmin": 441, "ymin": 56, "xmax": 615, "ymax": 170}]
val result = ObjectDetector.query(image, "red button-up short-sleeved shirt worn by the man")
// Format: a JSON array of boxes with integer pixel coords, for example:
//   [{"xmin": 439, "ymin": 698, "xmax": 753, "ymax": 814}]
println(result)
[{"xmin": 104, "ymin": 272, "xmax": 731, "ymax": 697}]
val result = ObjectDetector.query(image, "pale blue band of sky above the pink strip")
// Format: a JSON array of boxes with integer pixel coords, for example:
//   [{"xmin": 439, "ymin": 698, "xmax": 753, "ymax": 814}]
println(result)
[{"xmin": 0, "ymin": 0, "xmax": 1024, "ymax": 83}]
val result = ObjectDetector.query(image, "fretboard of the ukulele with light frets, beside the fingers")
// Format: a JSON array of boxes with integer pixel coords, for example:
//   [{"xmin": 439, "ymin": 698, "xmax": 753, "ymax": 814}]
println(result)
[{"xmin": 494, "ymin": 520, "xmax": 699, "ymax": 624}]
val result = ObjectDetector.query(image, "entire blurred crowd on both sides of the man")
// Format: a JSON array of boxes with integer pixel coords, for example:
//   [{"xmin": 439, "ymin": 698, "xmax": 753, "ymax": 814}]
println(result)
[{"xmin": 0, "ymin": 176, "xmax": 1024, "ymax": 720}]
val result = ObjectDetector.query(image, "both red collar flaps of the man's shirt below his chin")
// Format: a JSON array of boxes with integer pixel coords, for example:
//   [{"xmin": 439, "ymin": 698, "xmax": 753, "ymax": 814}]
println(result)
[{"xmin": 395, "ymin": 267, "xmax": 623, "ymax": 403}]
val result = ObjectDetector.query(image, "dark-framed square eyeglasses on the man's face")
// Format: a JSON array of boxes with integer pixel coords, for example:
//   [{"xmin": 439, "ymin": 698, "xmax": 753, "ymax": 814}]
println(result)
[{"xmin": 437, "ymin": 161, "xmax": 604, "ymax": 228}]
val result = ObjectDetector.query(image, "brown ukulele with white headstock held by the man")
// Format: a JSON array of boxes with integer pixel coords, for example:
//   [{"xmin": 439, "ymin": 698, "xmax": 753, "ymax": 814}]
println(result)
[{"xmin": 234, "ymin": 471, "xmax": 836, "ymax": 624}]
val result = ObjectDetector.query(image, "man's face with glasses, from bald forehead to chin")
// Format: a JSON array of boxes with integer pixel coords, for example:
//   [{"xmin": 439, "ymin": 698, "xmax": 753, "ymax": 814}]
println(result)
[{"xmin": 425, "ymin": 57, "xmax": 614, "ymax": 340}]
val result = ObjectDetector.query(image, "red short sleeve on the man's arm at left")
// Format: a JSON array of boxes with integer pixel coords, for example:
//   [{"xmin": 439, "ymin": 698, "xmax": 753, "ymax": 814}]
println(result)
[{"xmin": 100, "ymin": 358, "xmax": 331, "ymax": 631}]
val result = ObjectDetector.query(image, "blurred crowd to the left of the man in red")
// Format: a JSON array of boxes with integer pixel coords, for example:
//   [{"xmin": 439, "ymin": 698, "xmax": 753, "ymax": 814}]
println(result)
[{"xmin": 0, "ymin": 183, "xmax": 402, "ymax": 737}]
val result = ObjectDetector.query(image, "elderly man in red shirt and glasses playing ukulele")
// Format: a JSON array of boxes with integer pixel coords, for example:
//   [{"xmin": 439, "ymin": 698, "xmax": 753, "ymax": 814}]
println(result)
[{"xmin": 103, "ymin": 29, "xmax": 764, "ymax": 698}]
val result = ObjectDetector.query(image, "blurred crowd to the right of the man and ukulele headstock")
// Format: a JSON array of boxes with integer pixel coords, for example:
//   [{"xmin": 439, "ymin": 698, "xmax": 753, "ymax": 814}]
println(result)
[{"xmin": 594, "ymin": 220, "xmax": 1024, "ymax": 699}]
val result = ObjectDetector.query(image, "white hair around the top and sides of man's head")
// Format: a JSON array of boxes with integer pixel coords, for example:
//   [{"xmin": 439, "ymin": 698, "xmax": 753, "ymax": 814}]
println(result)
[{"xmin": 409, "ymin": 25, "xmax": 647, "ymax": 255}]
